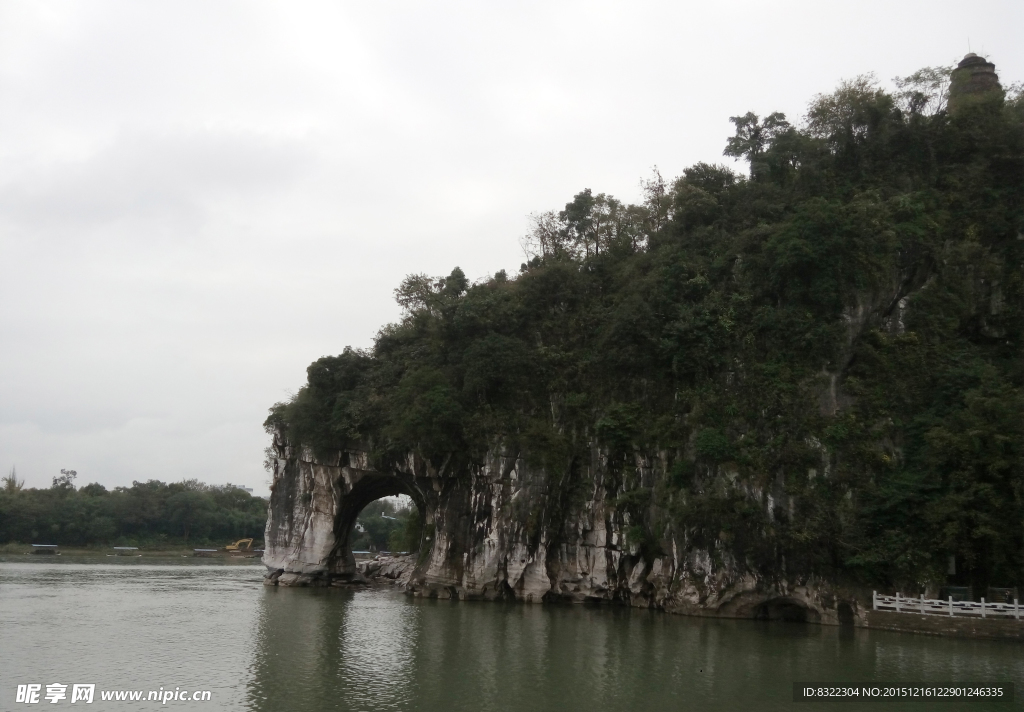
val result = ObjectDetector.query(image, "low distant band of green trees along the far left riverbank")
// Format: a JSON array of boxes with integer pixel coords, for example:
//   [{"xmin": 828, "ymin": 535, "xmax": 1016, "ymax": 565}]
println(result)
[{"xmin": 0, "ymin": 472, "xmax": 266, "ymax": 547}]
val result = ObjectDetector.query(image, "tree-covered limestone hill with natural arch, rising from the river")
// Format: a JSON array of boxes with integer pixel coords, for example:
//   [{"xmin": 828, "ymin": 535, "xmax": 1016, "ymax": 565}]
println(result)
[{"xmin": 264, "ymin": 54, "xmax": 1024, "ymax": 622}]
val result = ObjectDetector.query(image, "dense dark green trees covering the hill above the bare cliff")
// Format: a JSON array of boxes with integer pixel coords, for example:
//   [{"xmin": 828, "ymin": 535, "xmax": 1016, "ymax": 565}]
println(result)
[{"xmin": 267, "ymin": 69, "xmax": 1024, "ymax": 590}]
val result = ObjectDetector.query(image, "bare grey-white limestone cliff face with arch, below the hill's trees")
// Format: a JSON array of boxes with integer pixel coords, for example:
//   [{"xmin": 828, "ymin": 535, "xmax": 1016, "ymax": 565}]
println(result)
[{"xmin": 263, "ymin": 433, "xmax": 861, "ymax": 623}]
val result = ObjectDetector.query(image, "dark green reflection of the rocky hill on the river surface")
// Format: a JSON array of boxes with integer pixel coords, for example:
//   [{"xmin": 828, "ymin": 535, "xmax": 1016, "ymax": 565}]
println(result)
[{"xmin": 250, "ymin": 590, "xmax": 1024, "ymax": 712}]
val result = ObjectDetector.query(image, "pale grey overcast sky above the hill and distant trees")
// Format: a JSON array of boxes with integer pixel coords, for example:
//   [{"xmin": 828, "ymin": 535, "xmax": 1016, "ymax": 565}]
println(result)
[{"xmin": 0, "ymin": 0, "xmax": 1024, "ymax": 494}]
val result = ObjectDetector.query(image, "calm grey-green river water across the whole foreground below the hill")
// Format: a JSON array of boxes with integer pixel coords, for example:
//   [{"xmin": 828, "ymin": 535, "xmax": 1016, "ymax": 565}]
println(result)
[{"xmin": 0, "ymin": 557, "xmax": 1024, "ymax": 712}]
